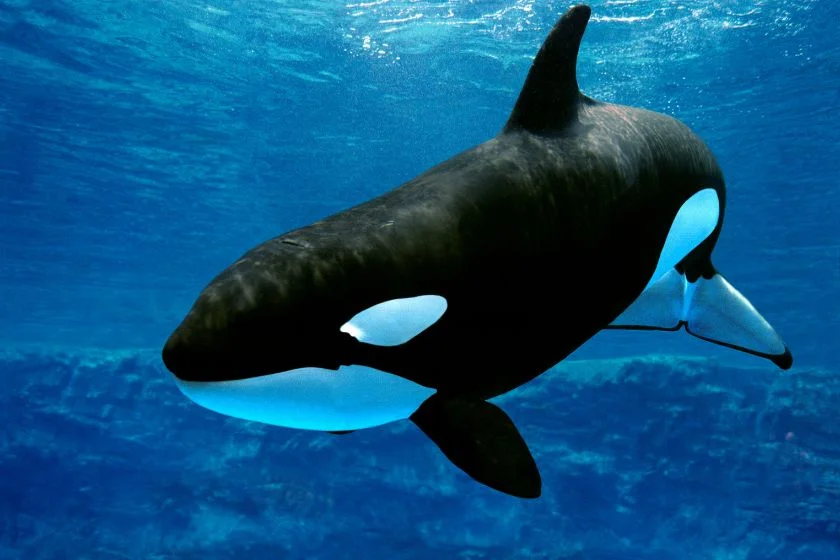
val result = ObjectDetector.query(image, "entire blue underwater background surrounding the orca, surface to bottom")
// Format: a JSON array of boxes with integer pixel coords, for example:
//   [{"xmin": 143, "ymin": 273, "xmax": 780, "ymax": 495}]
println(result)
[{"xmin": 0, "ymin": 0, "xmax": 840, "ymax": 560}]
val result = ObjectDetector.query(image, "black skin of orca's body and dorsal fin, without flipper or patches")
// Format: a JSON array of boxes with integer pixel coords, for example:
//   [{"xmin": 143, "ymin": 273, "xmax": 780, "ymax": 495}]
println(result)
[{"xmin": 163, "ymin": 6, "xmax": 725, "ymax": 399}]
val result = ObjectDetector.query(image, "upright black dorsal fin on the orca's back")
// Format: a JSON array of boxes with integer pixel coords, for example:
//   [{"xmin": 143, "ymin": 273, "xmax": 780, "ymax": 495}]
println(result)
[{"xmin": 504, "ymin": 5, "xmax": 592, "ymax": 133}]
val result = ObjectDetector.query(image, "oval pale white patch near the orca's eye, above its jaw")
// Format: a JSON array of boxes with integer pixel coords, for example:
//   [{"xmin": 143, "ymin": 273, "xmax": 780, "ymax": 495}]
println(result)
[{"xmin": 341, "ymin": 295, "xmax": 447, "ymax": 346}]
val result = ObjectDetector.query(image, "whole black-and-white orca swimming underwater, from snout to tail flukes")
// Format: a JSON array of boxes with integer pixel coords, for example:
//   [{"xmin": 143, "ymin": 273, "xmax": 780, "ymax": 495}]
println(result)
[{"xmin": 162, "ymin": 5, "xmax": 792, "ymax": 498}]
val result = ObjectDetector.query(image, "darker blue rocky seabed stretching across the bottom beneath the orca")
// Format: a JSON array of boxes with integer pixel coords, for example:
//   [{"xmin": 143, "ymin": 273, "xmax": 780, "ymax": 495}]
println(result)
[{"xmin": 0, "ymin": 350, "xmax": 840, "ymax": 560}]
